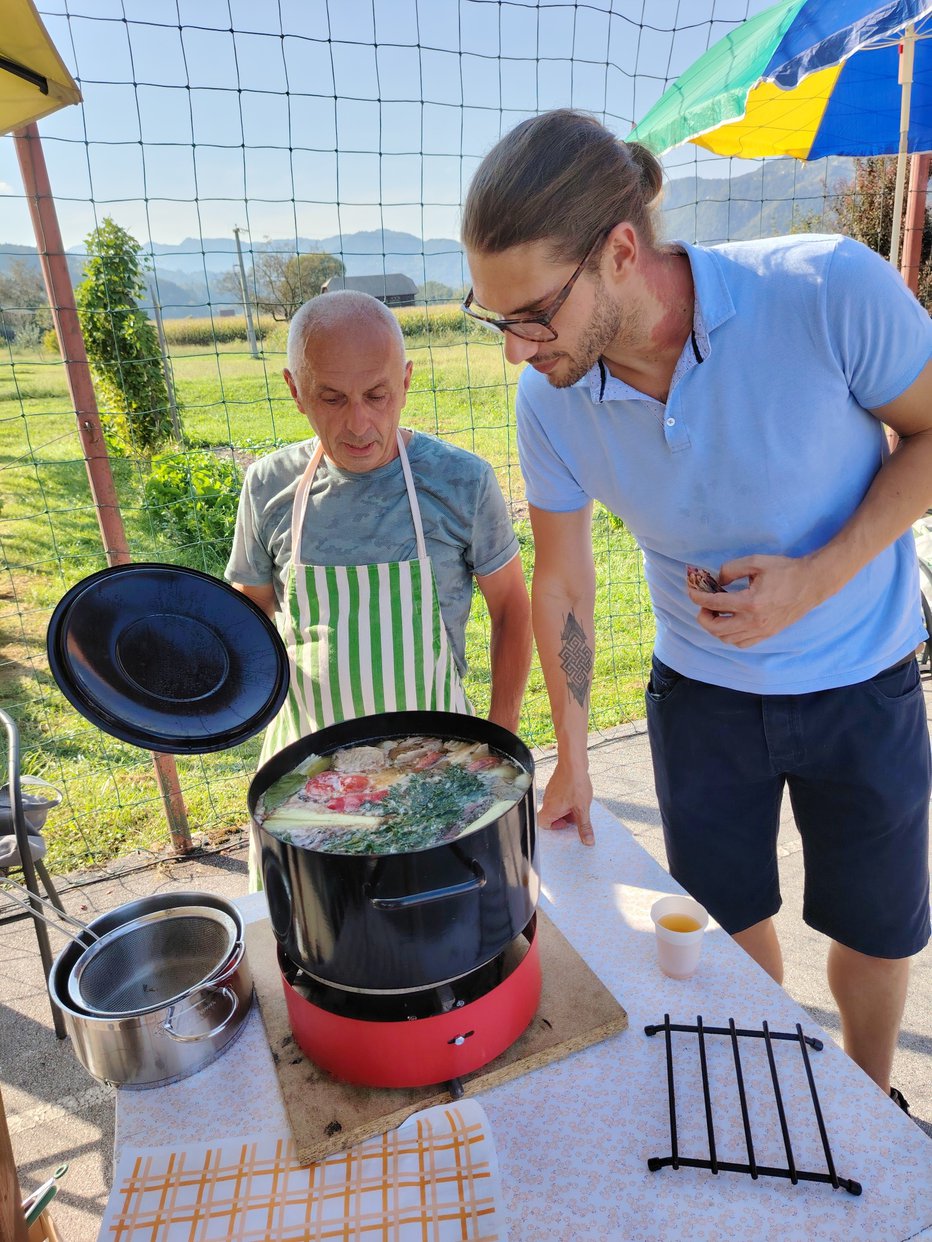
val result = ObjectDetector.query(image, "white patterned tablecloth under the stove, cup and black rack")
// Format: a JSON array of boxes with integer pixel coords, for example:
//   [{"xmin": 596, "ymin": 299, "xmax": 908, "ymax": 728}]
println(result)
[{"xmin": 117, "ymin": 804, "xmax": 932, "ymax": 1242}]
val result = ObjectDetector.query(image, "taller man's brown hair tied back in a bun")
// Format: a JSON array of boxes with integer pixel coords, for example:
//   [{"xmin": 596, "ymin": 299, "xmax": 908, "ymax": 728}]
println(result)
[{"xmin": 462, "ymin": 108, "xmax": 664, "ymax": 263}]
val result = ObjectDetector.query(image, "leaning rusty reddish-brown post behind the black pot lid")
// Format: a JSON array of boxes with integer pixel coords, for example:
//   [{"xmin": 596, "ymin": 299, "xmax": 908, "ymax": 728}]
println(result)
[{"xmin": 12, "ymin": 124, "xmax": 194, "ymax": 853}]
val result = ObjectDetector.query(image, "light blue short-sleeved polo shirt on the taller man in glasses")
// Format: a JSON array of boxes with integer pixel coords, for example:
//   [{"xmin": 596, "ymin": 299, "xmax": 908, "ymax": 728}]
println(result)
[{"xmin": 517, "ymin": 235, "xmax": 932, "ymax": 694}]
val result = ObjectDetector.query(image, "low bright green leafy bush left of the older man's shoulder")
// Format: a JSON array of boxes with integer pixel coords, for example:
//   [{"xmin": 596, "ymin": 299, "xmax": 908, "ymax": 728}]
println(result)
[{"xmin": 145, "ymin": 450, "xmax": 242, "ymax": 559}]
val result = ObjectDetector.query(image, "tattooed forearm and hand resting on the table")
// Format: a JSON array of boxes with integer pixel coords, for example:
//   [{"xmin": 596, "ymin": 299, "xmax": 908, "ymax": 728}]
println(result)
[{"xmin": 531, "ymin": 504, "xmax": 595, "ymax": 845}]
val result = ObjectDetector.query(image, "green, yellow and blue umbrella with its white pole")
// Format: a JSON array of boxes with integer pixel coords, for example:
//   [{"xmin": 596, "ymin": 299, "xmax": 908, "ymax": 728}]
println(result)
[{"xmin": 629, "ymin": 0, "xmax": 932, "ymax": 262}]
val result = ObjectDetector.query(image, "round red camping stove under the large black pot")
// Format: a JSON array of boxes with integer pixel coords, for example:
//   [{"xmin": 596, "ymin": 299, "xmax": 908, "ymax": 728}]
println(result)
[{"xmin": 278, "ymin": 915, "xmax": 541, "ymax": 1095}]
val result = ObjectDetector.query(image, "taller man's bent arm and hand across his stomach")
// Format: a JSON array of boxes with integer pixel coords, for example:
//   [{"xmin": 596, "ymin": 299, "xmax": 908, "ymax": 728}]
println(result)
[{"xmin": 690, "ymin": 363, "xmax": 932, "ymax": 647}]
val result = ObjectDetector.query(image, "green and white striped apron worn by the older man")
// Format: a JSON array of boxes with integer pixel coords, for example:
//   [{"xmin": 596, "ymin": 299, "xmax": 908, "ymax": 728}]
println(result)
[{"xmin": 250, "ymin": 431, "xmax": 472, "ymax": 892}]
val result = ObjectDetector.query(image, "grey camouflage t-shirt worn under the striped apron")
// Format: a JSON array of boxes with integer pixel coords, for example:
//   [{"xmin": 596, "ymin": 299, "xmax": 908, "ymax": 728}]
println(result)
[{"xmin": 225, "ymin": 431, "xmax": 518, "ymax": 672}]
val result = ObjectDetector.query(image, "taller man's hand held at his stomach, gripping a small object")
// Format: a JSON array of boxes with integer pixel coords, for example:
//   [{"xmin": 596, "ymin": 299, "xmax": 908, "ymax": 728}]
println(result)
[{"xmin": 687, "ymin": 556, "xmax": 841, "ymax": 647}]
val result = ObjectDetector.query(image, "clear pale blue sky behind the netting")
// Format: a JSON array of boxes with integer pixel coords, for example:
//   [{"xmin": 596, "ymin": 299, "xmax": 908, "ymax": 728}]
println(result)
[{"xmin": 0, "ymin": 0, "xmax": 765, "ymax": 246}]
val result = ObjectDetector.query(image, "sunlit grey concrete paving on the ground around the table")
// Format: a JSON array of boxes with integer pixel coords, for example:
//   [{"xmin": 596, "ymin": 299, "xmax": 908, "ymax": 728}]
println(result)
[{"xmin": 0, "ymin": 676, "xmax": 932, "ymax": 1242}]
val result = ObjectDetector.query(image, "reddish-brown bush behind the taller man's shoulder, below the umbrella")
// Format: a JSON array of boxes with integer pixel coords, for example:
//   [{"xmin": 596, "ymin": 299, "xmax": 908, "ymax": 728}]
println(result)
[{"xmin": 794, "ymin": 155, "xmax": 932, "ymax": 309}]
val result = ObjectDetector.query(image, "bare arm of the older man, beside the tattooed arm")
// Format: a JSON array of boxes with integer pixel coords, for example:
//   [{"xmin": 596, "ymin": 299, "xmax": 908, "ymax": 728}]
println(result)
[{"xmin": 476, "ymin": 555, "xmax": 531, "ymax": 733}]
